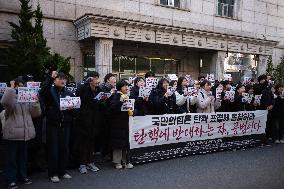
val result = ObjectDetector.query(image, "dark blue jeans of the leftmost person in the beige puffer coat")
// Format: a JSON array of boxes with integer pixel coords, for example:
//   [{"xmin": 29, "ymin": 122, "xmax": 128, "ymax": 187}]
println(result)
[{"xmin": 4, "ymin": 140, "xmax": 27, "ymax": 183}]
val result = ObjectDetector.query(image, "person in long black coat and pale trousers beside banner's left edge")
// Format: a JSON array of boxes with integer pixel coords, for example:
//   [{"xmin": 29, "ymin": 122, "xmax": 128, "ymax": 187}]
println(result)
[{"xmin": 110, "ymin": 80, "xmax": 133, "ymax": 169}]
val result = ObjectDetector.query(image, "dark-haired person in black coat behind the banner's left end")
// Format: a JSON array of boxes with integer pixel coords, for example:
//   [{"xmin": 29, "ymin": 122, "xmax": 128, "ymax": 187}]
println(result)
[{"xmin": 129, "ymin": 77, "xmax": 150, "ymax": 116}]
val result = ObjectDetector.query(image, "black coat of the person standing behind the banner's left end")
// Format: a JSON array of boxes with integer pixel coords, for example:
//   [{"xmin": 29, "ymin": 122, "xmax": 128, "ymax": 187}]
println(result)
[{"xmin": 129, "ymin": 85, "xmax": 151, "ymax": 116}]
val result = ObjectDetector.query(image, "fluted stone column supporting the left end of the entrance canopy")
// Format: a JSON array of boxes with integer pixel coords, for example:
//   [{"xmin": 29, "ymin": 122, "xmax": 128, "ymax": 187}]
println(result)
[{"xmin": 95, "ymin": 39, "xmax": 113, "ymax": 78}]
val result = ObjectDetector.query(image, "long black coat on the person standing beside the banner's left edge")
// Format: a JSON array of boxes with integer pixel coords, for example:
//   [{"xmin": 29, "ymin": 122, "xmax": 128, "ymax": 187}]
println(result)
[{"xmin": 110, "ymin": 93, "xmax": 129, "ymax": 150}]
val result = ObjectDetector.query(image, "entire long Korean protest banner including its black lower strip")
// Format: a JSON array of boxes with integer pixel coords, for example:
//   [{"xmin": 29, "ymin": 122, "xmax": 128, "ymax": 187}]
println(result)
[{"xmin": 129, "ymin": 110, "xmax": 268, "ymax": 163}]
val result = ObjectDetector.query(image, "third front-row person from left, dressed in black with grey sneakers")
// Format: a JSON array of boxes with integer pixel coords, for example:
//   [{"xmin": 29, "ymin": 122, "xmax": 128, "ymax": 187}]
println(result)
[{"xmin": 76, "ymin": 72, "xmax": 101, "ymax": 174}]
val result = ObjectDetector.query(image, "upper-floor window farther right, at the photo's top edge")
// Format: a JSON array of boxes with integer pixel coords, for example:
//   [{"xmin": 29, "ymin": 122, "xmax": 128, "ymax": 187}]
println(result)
[{"xmin": 217, "ymin": 0, "xmax": 235, "ymax": 18}]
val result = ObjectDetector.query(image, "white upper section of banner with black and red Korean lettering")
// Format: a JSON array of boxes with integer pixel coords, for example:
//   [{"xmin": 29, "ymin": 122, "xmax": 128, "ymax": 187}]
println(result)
[{"xmin": 129, "ymin": 110, "xmax": 267, "ymax": 149}]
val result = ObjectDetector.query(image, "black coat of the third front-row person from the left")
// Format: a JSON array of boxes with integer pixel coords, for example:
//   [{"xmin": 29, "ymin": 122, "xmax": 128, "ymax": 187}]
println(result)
[{"xmin": 76, "ymin": 84, "xmax": 101, "ymax": 138}]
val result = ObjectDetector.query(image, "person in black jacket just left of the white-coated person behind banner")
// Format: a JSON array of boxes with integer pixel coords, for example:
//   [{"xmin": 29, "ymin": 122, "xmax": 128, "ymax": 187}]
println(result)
[{"xmin": 150, "ymin": 79, "xmax": 180, "ymax": 115}]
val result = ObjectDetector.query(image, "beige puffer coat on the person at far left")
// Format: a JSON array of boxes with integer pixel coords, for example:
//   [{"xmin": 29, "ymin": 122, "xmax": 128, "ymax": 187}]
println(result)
[{"xmin": 1, "ymin": 88, "xmax": 41, "ymax": 141}]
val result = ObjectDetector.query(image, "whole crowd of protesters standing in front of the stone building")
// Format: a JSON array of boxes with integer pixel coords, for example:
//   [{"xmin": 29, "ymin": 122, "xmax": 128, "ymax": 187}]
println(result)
[{"xmin": 0, "ymin": 71, "xmax": 284, "ymax": 188}]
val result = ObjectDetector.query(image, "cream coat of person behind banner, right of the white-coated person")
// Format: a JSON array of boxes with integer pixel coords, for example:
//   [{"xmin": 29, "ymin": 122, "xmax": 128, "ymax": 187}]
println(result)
[{"xmin": 196, "ymin": 89, "xmax": 221, "ymax": 113}]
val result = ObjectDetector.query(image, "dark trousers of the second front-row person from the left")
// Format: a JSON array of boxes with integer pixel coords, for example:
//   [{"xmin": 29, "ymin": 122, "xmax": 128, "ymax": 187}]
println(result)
[{"xmin": 47, "ymin": 126, "xmax": 70, "ymax": 177}]
